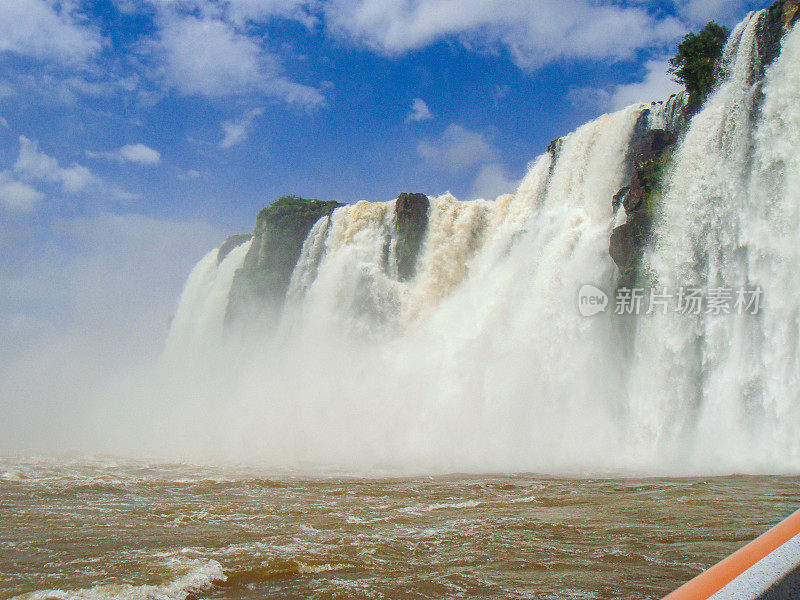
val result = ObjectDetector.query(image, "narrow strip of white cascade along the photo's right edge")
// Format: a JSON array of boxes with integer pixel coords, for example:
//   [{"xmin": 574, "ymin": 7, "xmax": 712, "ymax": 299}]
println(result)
[{"xmin": 742, "ymin": 17, "xmax": 800, "ymax": 460}]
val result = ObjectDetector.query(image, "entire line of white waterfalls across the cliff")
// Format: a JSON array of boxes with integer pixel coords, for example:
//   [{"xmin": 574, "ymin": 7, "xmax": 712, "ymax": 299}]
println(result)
[{"xmin": 161, "ymin": 5, "xmax": 800, "ymax": 473}]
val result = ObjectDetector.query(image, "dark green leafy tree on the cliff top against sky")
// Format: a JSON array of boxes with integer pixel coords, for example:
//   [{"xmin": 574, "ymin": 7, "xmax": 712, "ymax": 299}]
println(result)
[{"xmin": 669, "ymin": 21, "xmax": 729, "ymax": 107}]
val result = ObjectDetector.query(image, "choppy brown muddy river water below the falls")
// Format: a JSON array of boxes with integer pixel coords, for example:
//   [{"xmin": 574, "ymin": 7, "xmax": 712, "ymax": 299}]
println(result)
[{"xmin": 0, "ymin": 458, "xmax": 800, "ymax": 600}]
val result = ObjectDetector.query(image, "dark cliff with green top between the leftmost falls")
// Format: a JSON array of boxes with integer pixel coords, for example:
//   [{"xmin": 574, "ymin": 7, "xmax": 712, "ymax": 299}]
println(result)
[{"xmin": 225, "ymin": 196, "xmax": 342, "ymax": 323}]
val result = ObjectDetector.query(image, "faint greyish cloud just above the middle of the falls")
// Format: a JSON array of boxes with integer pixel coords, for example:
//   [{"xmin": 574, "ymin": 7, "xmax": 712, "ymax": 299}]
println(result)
[{"xmin": 417, "ymin": 123, "xmax": 498, "ymax": 173}]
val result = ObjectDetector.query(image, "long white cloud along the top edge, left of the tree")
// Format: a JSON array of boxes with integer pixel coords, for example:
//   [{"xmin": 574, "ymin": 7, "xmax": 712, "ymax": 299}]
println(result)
[{"xmin": 325, "ymin": 0, "xmax": 685, "ymax": 69}]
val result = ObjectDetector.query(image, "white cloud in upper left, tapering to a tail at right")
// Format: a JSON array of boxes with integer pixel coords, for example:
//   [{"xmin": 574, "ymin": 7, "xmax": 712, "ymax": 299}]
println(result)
[{"xmin": 156, "ymin": 10, "xmax": 324, "ymax": 108}]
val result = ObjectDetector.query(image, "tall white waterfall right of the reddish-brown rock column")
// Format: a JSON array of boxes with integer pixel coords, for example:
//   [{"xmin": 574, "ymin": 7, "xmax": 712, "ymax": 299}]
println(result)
[{"xmin": 628, "ymin": 11, "xmax": 800, "ymax": 470}]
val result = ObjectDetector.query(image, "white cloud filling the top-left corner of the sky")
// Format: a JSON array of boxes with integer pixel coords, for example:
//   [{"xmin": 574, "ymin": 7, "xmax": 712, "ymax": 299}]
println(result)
[{"xmin": 0, "ymin": 0, "xmax": 103, "ymax": 64}]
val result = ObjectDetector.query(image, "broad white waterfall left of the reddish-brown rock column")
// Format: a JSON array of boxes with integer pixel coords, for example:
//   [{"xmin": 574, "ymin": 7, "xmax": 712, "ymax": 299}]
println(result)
[{"xmin": 166, "ymin": 106, "xmax": 645, "ymax": 470}]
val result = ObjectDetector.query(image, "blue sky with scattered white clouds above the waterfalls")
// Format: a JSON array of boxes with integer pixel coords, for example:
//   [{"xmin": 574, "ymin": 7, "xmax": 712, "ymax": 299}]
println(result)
[{"xmin": 0, "ymin": 0, "xmax": 768, "ymax": 358}]
